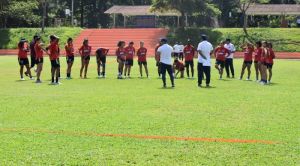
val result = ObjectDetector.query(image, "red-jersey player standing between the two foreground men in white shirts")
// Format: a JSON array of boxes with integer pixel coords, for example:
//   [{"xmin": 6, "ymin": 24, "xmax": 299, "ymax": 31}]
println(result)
[{"xmin": 183, "ymin": 39, "xmax": 196, "ymax": 78}]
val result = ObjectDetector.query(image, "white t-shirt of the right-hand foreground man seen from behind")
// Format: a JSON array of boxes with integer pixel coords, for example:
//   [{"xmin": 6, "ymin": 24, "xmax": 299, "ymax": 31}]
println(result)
[{"xmin": 197, "ymin": 41, "xmax": 214, "ymax": 66}]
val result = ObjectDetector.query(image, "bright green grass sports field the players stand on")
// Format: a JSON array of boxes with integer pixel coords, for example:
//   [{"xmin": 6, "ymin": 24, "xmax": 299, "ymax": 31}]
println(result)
[{"xmin": 0, "ymin": 56, "xmax": 300, "ymax": 165}]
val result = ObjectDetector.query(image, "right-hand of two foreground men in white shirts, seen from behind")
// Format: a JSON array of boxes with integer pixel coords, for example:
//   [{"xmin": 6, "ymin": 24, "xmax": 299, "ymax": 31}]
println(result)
[{"xmin": 197, "ymin": 35, "xmax": 214, "ymax": 87}]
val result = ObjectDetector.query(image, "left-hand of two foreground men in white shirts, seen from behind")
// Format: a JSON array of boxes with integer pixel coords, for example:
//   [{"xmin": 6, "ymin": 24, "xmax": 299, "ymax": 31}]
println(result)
[{"xmin": 157, "ymin": 38, "xmax": 175, "ymax": 88}]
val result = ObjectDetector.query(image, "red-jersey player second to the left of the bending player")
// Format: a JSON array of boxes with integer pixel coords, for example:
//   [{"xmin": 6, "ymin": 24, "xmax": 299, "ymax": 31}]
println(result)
[{"xmin": 65, "ymin": 38, "xmax": 75, "ymax": 79}]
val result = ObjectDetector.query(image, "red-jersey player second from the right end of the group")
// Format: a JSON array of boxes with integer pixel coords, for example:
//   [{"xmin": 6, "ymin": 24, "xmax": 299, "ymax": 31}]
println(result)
[{"xmin": 260, "ymin": 41, "xmax": 270, "ymax": 85}]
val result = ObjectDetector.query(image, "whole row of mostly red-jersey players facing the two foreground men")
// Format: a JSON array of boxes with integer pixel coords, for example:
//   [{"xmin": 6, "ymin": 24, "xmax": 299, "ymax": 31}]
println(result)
[{"xmin": 18, "ymin": 35, "xmax": 275, "ymax": 85}]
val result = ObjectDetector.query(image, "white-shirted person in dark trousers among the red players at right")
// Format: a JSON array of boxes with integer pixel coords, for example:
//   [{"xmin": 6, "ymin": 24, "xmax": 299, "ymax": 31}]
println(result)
[{"xmin": 224, "ymin": 39, "xmax": 236, "ymax": 78}]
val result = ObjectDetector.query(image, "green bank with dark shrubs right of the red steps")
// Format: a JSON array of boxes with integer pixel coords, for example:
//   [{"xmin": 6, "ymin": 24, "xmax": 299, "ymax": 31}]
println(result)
[{"xmin": 168, "ymin": 28, "xmax": 300, "ymax": 52}]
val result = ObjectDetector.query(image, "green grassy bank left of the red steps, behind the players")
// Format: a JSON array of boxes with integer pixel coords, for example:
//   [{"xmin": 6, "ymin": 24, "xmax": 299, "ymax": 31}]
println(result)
[{"xmin": 0, "ymin": 27, "xmax": 81, "ymax": 49}]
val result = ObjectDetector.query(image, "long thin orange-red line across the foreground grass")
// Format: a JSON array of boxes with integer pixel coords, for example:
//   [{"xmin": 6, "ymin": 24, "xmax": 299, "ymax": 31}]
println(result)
[{"xmin": 0, "ymin": 128, "xmax": 278, "ymax": 144}]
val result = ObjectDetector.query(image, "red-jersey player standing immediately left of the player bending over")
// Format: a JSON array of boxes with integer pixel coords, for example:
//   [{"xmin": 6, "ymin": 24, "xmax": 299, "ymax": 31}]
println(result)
[{"xmin": 79, "ymin": 39, "xmax": 92, "ymax": 79}]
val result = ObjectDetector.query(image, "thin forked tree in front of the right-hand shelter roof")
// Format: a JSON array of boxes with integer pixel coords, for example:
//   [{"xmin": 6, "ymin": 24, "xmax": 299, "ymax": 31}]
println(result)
[{"xmin": 237, "ymin": 0, "xmax": 269, "ymax": 39}]
